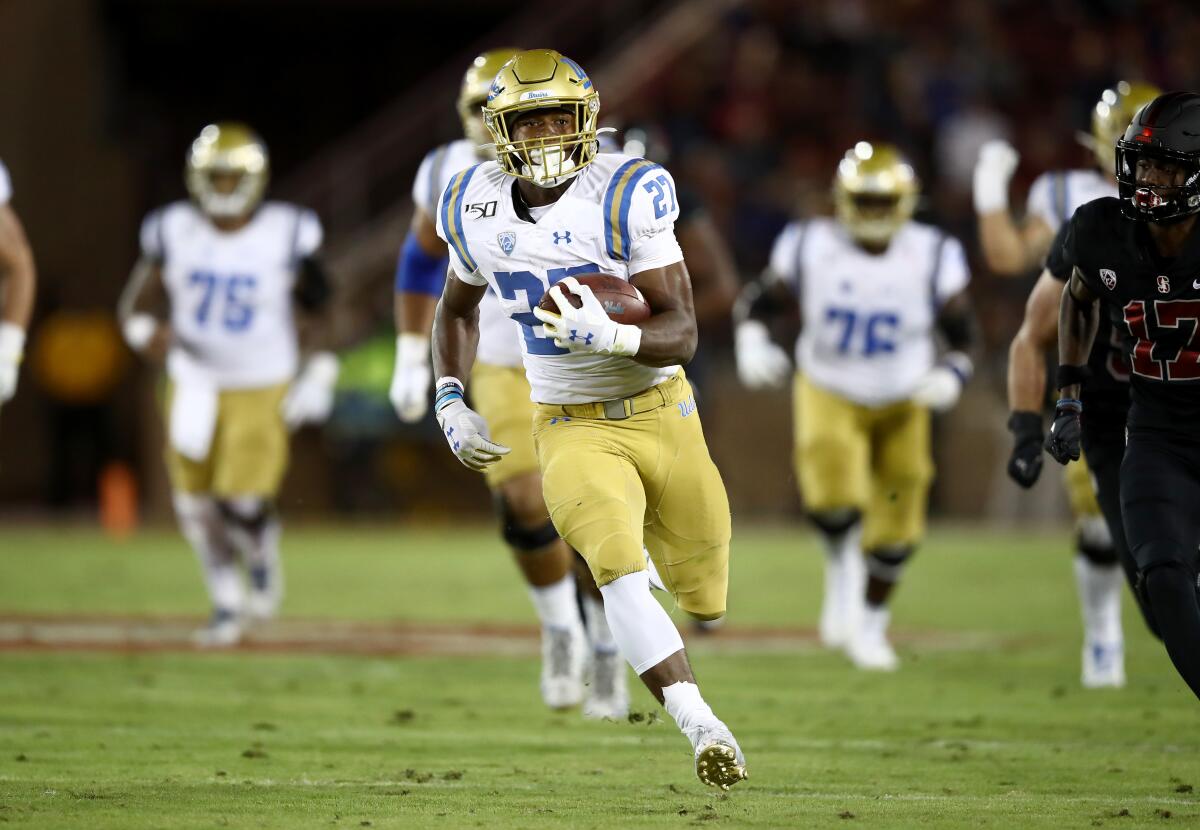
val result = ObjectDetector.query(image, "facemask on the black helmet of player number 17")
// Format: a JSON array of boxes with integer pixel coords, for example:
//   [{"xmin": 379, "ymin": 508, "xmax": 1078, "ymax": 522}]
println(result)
[{"xmin": 1116, "ymin": 139, "xmax": 1200, "ymax": 224}]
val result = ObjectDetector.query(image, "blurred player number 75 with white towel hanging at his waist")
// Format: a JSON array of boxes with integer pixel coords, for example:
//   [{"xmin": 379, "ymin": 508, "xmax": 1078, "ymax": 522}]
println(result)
[{"xmin": 119, "ymin": 124, "xmax": 337, "ymax": 645}]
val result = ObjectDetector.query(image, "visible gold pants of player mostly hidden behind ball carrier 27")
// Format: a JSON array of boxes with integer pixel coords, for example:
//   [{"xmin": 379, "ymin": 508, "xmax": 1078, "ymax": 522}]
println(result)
[{"xmin": 470, "ymin": 363, "xmax": 538, "ymax": 489}]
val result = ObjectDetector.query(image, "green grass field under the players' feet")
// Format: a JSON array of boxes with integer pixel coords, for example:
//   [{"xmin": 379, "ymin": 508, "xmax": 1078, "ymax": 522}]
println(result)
[{"xmin": 0, "ymin": 525, "xmax": 1200, "ymax": 830}]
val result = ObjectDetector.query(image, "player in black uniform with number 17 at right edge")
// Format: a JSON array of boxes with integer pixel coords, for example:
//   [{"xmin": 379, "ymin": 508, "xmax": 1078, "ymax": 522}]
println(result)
[{"xmin": 1046, "ymin": 92, "xmax": 1200, "ymax": 697}]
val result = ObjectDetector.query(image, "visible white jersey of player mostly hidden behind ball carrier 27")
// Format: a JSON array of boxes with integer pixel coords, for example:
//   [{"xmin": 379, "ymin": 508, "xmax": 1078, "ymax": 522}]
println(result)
[{"xmin": 413, "ymin": 138, "xmax": 521, "ymax": 367}]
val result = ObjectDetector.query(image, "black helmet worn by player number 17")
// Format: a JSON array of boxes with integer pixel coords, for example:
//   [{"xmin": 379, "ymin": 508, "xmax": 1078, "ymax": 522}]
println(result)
[{"xmin": 1116, "ymin": 92, "xmax": 1200, "ymax": 223}]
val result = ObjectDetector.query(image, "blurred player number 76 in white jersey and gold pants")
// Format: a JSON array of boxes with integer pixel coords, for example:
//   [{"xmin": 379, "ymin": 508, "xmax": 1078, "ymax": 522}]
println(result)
[{"xmin": 736, "ymin": 142, "xmax": 972, "ymax": 670}]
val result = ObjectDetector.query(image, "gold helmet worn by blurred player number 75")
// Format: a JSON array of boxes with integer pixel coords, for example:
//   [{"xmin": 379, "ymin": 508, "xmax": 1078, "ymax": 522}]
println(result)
[{"xmin": 184, "ymin": 121, "xmax": 270, "ymax": 218}]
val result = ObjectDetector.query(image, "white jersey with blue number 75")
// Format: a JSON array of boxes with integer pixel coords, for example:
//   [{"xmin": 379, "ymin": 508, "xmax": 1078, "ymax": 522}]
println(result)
[{"xmin": 142, "ymin": 202, "xmax": 323, "ymax": 389}]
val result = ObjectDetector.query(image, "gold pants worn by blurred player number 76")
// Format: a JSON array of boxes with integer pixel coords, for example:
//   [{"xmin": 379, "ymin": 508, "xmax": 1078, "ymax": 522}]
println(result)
[{"xmin": 793, "ymin": 374, "xmax": 934, "ymax": 551}]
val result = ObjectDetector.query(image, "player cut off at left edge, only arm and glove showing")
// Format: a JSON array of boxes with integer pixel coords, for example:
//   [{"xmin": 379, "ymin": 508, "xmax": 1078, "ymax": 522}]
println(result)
[{"xmin": 0, "ymin": 162, "xmax": 37, "ymax": 407}]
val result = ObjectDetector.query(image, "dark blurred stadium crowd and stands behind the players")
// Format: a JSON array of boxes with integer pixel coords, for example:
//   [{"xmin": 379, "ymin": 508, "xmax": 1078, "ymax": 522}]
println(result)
[{"xmin": 0, "ymin": 0, "xmax": 1200, "ymax": 516}]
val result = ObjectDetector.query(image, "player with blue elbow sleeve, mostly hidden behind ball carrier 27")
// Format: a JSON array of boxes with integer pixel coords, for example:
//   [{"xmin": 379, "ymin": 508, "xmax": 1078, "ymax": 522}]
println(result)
[{"xmin": 390, "ymin": 49, "xmax": 629, "ymax": 718}]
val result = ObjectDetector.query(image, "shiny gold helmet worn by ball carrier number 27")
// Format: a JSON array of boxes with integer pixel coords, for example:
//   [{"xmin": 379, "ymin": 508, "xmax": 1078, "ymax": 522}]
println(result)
[{"xmin": 484, "ymin": 49, "xmax": 600, "ymax": 187}]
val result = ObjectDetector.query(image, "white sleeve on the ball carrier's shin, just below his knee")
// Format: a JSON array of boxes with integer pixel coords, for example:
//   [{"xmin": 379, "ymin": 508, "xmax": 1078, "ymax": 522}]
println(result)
[{"xmin": 600, "ymin": 571, "xmax": 683, "ymax": 675}]
